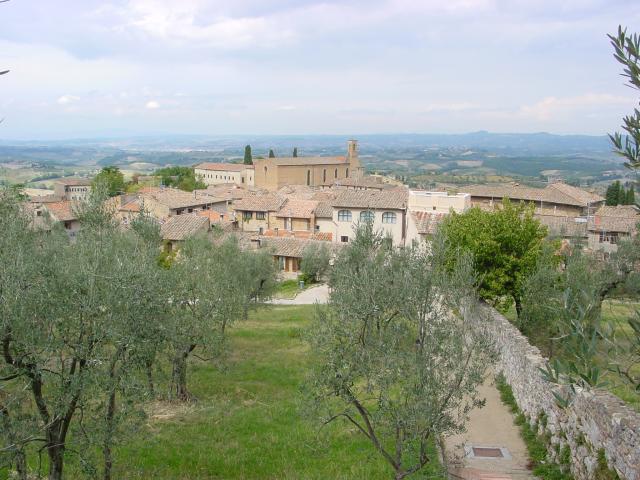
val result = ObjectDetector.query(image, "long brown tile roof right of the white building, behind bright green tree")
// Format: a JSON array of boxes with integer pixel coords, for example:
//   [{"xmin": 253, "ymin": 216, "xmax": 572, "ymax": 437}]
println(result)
[{"xmin": 461, "ymin": 183, "xmax": 603, "ymax": 207}]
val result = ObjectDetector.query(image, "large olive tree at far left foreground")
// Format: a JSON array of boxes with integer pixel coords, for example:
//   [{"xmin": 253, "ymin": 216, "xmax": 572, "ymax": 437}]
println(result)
[{"xmin": 0, "ymin": 186, "xmax": 169, "ymax": 480}]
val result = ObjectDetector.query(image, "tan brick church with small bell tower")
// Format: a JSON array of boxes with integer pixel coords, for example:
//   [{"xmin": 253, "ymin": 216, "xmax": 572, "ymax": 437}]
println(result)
[{"xmin": 254, "ymin": 140, "xmax": 364, "ymax": 191}]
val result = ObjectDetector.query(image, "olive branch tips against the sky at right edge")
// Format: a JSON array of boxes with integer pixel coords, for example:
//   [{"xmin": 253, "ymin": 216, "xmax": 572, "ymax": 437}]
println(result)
[{"xmin": 608, "ymin": 26, "xmax": 640, "ymax": 170}]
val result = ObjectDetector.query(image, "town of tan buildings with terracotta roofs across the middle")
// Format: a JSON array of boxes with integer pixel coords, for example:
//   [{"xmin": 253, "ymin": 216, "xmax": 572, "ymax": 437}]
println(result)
[{"xmin": 29, "ymin": 140, "xmax": 640, "ymax": 274}]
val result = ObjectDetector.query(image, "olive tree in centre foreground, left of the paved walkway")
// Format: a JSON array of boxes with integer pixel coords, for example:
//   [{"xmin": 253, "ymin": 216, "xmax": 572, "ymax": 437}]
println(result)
[{"xmin": 305, "ymin": 225, "xmax": 493, "ymax": 480}]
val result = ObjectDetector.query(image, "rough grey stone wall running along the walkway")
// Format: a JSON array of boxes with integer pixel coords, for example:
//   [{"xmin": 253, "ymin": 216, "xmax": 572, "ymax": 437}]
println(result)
[{"xmin": 474, "ymin": 305, "xmax": 640, "ymax": 480}]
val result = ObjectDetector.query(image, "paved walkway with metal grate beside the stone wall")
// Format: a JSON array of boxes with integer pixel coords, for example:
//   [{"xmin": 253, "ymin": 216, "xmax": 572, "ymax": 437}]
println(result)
[{"xmin": 445, "ymin": 376, "xmax": 536, "ymax": 480}]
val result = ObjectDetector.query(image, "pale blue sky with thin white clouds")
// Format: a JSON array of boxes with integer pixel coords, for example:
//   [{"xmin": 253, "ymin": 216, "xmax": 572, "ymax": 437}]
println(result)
[{"xmin": 0, "ymin": 0, "xmax": 640, "ymax": 140}]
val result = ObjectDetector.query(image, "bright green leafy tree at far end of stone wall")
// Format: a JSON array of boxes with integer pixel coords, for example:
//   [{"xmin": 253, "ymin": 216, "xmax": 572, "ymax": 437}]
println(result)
[{"xmin": 441, "ymin": 199, "xmax": 547, "ymax": 317}]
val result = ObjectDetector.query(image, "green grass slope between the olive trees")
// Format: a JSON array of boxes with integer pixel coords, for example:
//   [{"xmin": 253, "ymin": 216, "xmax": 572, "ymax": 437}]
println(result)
[{"xmin": 47, "ymin": 306, "xmax": 444, "ymax": 480}]
